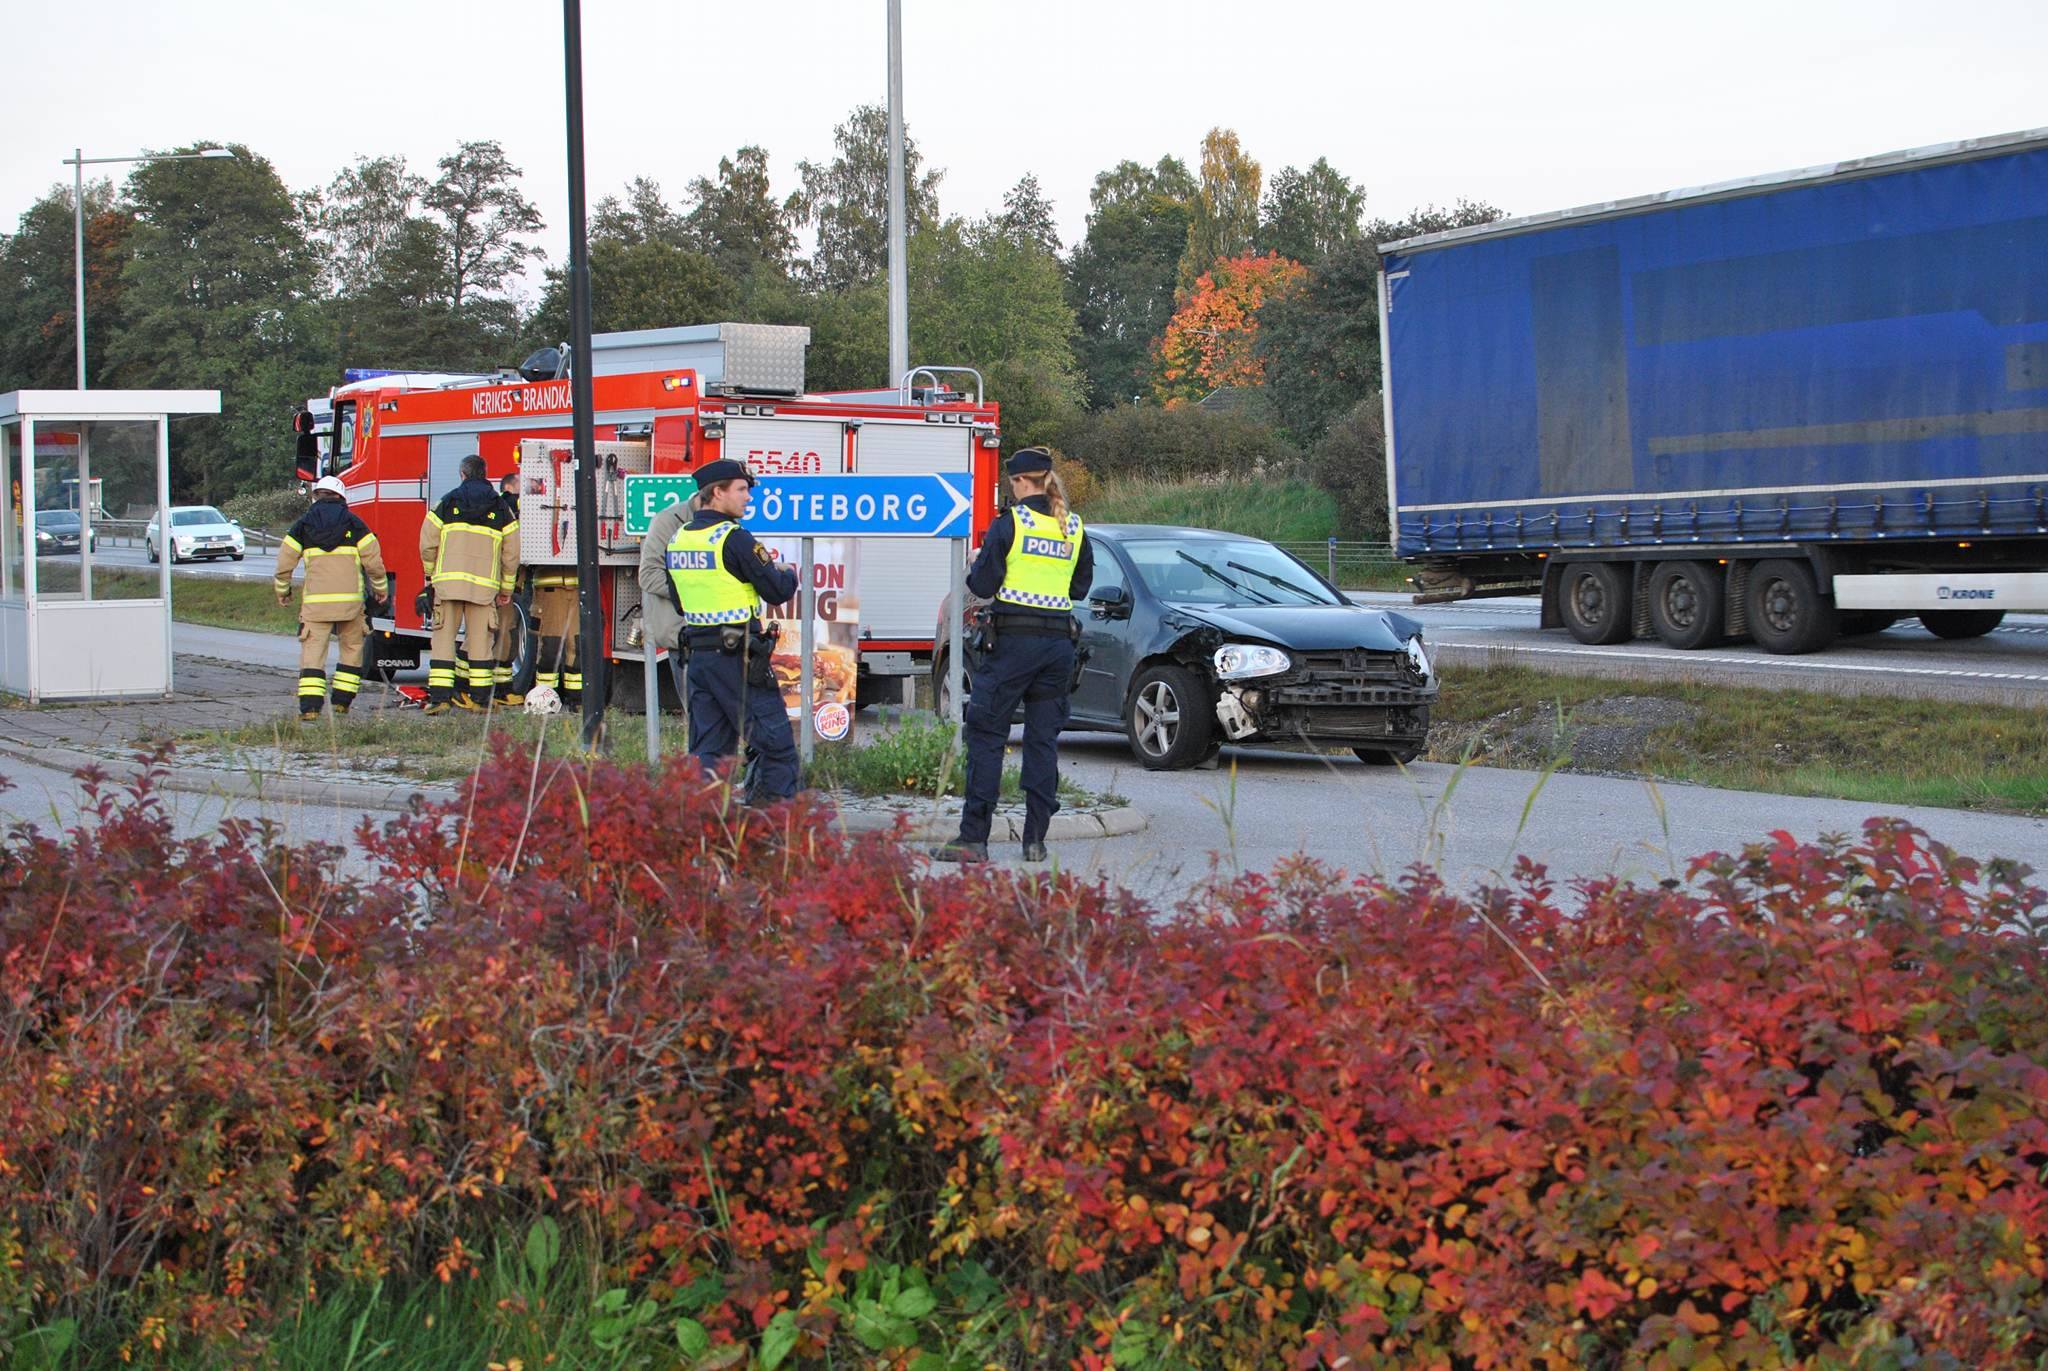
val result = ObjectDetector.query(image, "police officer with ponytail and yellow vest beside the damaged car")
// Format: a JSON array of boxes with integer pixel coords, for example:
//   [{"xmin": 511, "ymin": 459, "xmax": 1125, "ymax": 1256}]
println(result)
[{"xmin": 934, "ymin": 447, "xmax": 1096, "ymax": 861}]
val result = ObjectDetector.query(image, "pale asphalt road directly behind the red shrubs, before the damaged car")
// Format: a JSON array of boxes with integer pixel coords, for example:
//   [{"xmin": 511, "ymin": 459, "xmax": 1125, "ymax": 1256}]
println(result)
[{"xmin": 0, "ymin": 623, "xmax": 2048, "ymax": 904}]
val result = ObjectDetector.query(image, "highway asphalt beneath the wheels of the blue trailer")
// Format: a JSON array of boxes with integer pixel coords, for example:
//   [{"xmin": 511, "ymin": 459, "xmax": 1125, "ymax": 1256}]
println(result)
[{"xmin": 1350, "ymin": 590, "xmax": 2048, "ymax": 707}]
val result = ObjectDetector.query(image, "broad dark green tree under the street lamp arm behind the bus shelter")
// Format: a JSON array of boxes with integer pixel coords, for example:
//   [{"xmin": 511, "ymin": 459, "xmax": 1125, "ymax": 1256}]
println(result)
[{"xmin": 109, "ymin": 146, "xmax": 336, "ymax": 500}]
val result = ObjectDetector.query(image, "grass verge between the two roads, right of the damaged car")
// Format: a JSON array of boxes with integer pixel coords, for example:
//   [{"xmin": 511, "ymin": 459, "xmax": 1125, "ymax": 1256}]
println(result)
[{"xmin": 1430, "ymin": 666, "xmax": 2048, "ymax": 814}]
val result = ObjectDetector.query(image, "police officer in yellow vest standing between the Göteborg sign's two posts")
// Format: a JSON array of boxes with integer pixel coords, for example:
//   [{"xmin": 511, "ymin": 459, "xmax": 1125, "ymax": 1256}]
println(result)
[{"xmin": 668, "ymin": 459, "xmax": 797, "ymax": 803}]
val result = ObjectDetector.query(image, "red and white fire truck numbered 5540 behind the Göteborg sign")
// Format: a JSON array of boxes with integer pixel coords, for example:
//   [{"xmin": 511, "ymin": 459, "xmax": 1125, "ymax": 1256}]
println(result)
[{"xmin": 295, "ymin": 324, "xmax": 1001, "ymax": 701}]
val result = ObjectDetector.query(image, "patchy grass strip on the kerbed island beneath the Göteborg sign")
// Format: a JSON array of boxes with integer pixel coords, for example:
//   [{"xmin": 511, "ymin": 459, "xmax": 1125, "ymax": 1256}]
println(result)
[{"xmin": 176, "ymin": 704, "xmax": 1130, "ymax": 805}]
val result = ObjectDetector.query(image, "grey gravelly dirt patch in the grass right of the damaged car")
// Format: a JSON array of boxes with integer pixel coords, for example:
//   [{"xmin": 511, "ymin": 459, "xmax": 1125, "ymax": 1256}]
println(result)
[{"xmin": 1430, "ymin": 695, "xmax": 1700, "ymax": 775}]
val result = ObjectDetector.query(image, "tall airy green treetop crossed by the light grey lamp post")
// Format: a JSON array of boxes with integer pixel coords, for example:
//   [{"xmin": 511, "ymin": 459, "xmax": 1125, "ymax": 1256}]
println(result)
[{"xmin": 793, "ymin": 105, "xmax": 944, "ymax": 291}]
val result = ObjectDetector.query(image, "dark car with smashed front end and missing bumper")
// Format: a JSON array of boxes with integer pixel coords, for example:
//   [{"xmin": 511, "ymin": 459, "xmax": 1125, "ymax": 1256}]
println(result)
[{"xmin": 932, "ymin": 525, "xmax": 1438, "ymax": 771}]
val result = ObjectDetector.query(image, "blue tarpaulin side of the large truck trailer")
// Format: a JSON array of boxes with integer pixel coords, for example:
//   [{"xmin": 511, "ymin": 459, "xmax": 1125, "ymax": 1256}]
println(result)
[{"xmin": 1384, "ymin": 135, "xmax": 2048, "ymax": 555}]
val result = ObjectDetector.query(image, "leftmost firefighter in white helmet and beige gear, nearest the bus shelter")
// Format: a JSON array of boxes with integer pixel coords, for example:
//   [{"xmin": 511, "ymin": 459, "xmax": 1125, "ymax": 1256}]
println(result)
[{"xmin": 272, "ymin": 475, "xmax": 391, "ymax": 723}]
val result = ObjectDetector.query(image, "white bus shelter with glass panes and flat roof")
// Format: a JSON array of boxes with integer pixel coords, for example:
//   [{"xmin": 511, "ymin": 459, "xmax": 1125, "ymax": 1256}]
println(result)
[{"xmin": 0, "ymin": 389, "xmax": 221, "ymax": 703}]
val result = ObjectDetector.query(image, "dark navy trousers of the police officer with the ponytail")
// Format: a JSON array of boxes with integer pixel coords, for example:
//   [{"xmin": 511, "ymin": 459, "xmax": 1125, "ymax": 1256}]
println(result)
[{"xmin": 961, "ymin": 629, "xmax": 1073, "ymax": 842}]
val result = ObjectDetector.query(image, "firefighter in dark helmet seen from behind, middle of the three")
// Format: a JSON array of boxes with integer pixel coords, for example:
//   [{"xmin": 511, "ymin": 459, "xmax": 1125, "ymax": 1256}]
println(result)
[{"xmin": 420, "ymin": 457, "xmax": 518, "ymax": 713}]
